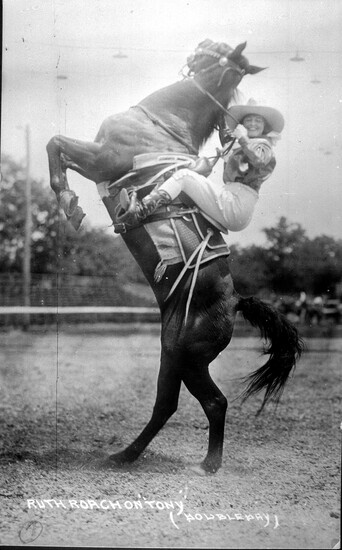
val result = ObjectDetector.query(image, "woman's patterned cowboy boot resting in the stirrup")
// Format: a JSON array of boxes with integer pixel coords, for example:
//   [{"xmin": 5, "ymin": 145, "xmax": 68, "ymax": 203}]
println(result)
[{"xmin": 117, "ymin": 189, "xmax": 172, "ymax": 227}]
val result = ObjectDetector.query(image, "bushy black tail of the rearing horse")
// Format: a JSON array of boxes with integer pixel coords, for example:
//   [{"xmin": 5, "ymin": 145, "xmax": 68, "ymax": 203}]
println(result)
[{"xmin": 237, "ymin": 297, "xmax": 304, "ymax": 412}]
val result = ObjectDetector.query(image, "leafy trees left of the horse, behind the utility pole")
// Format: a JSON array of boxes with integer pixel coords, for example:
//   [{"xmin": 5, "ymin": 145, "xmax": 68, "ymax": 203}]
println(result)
[{"xmin": 0, "ymin": 155, "xmax": 146, "ymax": 283}]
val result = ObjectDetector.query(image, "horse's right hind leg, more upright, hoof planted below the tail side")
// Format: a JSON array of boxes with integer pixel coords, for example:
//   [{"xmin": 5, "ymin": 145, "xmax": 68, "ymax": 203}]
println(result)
[{"xmin": 183, "ymin": 365, "xmax": 227, "ymax": 473}]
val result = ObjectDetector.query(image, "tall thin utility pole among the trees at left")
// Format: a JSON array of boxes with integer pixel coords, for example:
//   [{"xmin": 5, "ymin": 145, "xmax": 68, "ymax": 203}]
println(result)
[{"xmin": 23, "ymin": 124, "xmax": 32, "ymax": 330}]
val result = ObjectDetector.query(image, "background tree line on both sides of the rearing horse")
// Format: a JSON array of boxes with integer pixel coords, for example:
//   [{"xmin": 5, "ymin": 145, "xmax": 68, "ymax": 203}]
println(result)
[{"xmin": 0, "ymin": 155, "xmax": 342, "ymax": 302}]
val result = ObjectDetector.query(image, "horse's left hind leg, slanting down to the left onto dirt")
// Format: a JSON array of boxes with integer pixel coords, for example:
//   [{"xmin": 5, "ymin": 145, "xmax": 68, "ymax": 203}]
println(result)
[{"xmin": 106, "ymin": 353, "xmax": 182, "ymax": 467}]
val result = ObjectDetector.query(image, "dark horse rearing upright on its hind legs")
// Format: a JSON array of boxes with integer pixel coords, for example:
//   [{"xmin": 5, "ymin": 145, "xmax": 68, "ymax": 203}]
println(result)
[{"xmin": 47, "ymin": 40, "xmax": 302, "ymax": 472}]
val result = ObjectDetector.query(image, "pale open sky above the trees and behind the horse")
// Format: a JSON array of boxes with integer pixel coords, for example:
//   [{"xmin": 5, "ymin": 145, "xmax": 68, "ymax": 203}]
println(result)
[{"xmin": 1, "ymin": 0, "xmax": 342, "ymax": 246}]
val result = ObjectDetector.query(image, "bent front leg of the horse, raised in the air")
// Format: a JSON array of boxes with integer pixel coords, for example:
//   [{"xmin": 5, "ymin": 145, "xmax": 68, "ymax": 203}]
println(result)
[{"xmin": 46, "ymin": 136, "xmax": 100, "ymax": 229}]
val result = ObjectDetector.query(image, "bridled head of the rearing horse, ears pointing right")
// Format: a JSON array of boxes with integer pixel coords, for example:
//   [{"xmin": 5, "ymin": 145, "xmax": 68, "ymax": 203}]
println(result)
[{"xmin": 187, "ymin": 39, "xmax": 263, "ymax": 85}]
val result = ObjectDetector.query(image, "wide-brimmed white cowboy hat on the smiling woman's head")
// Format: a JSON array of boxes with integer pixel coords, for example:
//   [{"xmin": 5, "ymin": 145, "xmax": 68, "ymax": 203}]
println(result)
[{"xmin": 227, "ymin": 100, "xmax": 285, "ymax": 134}]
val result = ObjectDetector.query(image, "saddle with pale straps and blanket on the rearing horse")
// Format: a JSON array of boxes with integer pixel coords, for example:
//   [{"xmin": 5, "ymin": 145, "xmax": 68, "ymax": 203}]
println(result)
[{"xmin": 98, "ymin": 153, "xmax": 230, "ymax": 316}]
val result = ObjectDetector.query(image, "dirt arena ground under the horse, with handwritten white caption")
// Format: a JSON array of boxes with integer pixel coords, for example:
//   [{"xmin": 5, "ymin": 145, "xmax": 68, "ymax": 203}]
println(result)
[{"xmin": 0, "ymin": 325, "xmax": 342, "ymax": 548}]
